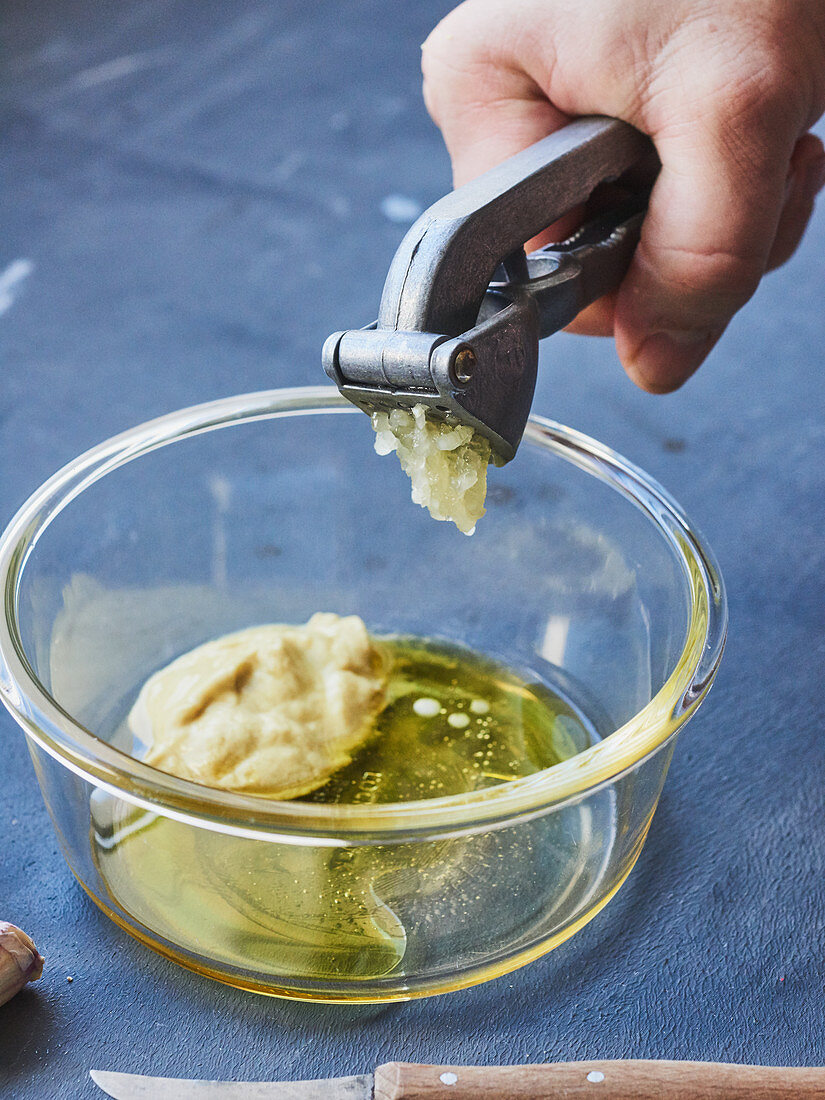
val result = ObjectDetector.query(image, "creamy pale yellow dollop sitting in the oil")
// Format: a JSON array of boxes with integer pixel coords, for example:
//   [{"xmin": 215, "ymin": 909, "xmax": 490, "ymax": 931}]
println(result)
[{"xmin": 129, "ymin": 613, "xmax": 387, "ymax": 799}]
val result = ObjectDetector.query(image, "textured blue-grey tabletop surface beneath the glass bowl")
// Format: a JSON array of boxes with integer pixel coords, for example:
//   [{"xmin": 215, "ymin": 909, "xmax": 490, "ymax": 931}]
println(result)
[{"xmin": 0, "ymin": 0, "xmax": 825, "ymax": 1100}]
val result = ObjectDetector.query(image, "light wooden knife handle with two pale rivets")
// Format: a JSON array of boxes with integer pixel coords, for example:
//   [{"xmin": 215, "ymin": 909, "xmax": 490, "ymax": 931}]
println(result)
[{"xmin": 374, "ymin": 1062, "xmax": 825, "ymax": 1100}]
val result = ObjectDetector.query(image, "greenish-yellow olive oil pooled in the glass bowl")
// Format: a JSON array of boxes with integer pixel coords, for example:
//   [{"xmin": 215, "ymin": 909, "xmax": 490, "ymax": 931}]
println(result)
[{"xmin": 91, "ymin": 637, "xmax": 604, "ymax": 996}]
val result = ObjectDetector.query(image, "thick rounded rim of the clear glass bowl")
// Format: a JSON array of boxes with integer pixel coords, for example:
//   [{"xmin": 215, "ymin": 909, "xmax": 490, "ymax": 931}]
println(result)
[{"xmin": 0, "ymin": 386, "xmax": 727, "ymax": 845}]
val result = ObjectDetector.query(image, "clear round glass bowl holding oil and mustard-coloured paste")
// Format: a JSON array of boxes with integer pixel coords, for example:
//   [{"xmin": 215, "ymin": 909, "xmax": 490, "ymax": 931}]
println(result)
[{"xmin": 0, "ymin": 387, "xmax": 726, "ymax": 1002}]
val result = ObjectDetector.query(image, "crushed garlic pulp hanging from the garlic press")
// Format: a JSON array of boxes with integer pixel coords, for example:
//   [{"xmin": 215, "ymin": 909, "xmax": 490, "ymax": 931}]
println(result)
[{"xmin": 372, "ymin": 405, "xmax": 491, "ymax": 535}]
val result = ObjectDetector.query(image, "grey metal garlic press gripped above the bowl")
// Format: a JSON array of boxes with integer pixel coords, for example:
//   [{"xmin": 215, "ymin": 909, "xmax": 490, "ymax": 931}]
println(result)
[{"xmin": 323, "ymin": 117, "xmax": 652, "ymax": 463}]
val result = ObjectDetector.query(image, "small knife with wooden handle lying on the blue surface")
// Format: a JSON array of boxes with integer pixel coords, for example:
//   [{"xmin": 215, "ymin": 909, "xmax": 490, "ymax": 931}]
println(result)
[{"xmin": 91, "ymin": 1060, "xmax": 825, "ymax": 1100}]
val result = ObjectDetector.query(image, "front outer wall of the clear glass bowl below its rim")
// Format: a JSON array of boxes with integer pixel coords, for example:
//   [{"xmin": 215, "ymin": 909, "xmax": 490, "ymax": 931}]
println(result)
[{"xmin": 30, "ymin": 740, "xmax": 673, "ymax": 1002}]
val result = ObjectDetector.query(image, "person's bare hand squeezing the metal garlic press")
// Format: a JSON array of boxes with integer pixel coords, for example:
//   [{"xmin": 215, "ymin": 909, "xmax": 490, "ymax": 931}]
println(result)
[{"xmin": 422, "ymin": 0, "xmax": 825, "ymax": 393}]
